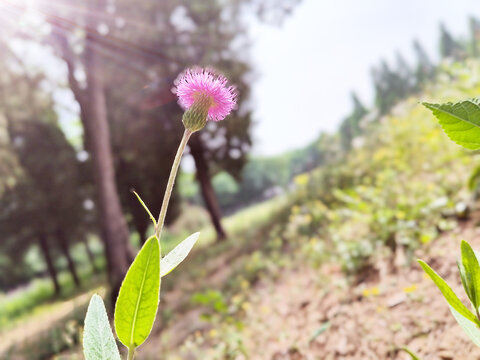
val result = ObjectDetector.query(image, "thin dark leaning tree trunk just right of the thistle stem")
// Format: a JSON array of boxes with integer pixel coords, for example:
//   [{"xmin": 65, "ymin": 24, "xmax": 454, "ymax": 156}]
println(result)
[{"xmin": 189, "ymin": 135, "xmax": 227, "ymax": 241}]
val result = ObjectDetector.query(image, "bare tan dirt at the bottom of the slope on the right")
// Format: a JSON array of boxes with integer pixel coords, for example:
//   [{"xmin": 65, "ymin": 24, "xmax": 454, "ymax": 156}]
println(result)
[{"xmin": 139, "ymin": 222, "xmax": 480, "ymax": 360}]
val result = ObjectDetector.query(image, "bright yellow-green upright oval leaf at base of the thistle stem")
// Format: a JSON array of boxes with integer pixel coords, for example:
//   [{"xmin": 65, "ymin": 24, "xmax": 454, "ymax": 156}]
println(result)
[{"xmin": 115, "ymin": 236, "xmax": 160, "ymax": 349}]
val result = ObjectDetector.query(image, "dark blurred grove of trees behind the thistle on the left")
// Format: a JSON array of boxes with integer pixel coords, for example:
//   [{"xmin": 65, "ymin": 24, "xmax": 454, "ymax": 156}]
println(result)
[{"xmin": 0, "ymin": 0, "xmax": 298, "ymax": 296}]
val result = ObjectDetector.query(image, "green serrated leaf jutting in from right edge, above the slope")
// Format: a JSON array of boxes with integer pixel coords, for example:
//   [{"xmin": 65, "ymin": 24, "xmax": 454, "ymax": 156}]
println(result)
[{"xmin": 423, "ymin": 99, "xmax": 480, "ymax": 150}]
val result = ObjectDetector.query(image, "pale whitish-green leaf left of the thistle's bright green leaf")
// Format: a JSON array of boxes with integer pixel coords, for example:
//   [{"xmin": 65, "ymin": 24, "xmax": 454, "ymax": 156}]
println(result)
[{"xmin": 83, "ymin": 295, "xmax": 120, "ymax": 360}]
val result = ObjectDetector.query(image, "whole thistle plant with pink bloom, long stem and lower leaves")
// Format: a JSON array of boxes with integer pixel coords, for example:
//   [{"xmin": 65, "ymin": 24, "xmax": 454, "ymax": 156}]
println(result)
[{"xmin": 83, "ymin": 69, "xmax": 236, "ymax": 360}]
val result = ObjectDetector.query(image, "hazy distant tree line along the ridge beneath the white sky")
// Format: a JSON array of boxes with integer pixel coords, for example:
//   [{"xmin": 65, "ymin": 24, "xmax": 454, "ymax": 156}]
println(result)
[{"xmin": 183, "ymin": 18, "xmax": 480, "ymax": 213}]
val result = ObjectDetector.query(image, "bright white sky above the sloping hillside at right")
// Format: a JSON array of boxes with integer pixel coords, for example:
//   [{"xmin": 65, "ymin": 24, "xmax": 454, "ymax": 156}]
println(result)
[{"xmin": 251, "ymin": 0, "xmax": 480, "ymax": 155}]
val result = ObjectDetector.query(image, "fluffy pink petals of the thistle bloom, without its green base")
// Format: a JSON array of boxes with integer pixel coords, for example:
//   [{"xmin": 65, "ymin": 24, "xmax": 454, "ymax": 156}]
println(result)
[{"xmin": 174, "ymin": 68, "xmax": 237, "ymax": 121}]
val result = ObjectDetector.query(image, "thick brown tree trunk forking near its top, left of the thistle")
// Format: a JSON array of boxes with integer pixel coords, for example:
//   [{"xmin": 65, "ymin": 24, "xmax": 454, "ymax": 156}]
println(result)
[{"xmin": 52, "ymin": 0, "xmax": 134, "ymax": 305}]
